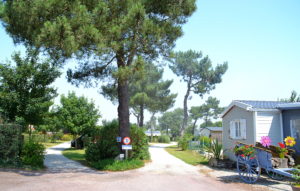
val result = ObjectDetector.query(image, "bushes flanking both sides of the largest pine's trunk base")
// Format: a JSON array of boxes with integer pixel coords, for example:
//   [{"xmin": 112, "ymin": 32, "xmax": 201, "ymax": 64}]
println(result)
[{"xmin": 86, "ymin": 120, "xmax": 150, "ymax": 162}]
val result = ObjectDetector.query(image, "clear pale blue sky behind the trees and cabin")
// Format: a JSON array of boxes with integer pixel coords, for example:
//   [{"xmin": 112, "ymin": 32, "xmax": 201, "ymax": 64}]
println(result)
[{"xmin": 0, "ymin": 0, "xmax": 300, "ymax": 122}]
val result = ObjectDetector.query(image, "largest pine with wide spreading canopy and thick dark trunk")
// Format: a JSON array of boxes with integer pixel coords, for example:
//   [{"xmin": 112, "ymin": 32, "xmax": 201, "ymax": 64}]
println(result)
[{"xmin": 0, "ymin": 0, "xmax": 196, "ymax": 140}]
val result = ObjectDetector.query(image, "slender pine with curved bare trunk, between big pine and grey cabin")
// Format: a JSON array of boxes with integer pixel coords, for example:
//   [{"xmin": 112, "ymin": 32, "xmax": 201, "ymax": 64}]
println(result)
[{"xmin": 169, "ymin": 50, "xmax": 228, "ymax": 135}]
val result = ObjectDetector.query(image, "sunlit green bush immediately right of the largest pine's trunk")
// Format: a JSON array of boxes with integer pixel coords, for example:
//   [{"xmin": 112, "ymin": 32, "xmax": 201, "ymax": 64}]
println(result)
[{"xmin": 130, "ymin": 125, "xmax": 150, "ymax": 160}]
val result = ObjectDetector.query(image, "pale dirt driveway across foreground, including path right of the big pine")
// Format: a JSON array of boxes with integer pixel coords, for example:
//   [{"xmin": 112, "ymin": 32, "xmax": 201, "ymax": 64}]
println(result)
[{"xmin": 0, "ymin": 145, "xmax": 286, "ymax": 191}]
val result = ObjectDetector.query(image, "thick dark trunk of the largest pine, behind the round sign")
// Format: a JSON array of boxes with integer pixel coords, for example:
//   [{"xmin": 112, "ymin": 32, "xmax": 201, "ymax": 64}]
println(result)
[{"xmin": 117, "ymin": 57, "xmax": 130, "ymax": 149}]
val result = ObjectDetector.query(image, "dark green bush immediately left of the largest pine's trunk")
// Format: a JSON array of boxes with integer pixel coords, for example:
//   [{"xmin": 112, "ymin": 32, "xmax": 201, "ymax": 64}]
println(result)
[{"xmin": 86, "ymin": 120, "xmax": 120, "ymax": 162}]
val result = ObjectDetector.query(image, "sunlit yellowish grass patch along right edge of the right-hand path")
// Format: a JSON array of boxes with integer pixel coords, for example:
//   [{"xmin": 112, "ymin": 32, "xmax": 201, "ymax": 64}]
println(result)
[{"xmin": 165, "ymin": 146, "xmax": 208, "ymax": 166}]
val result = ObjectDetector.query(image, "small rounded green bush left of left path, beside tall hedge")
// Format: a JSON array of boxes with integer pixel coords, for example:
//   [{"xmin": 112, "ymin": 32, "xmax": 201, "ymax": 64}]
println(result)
[{"xmin": 21, "ymin": 140, "xmax": 45, "ymax": 168}]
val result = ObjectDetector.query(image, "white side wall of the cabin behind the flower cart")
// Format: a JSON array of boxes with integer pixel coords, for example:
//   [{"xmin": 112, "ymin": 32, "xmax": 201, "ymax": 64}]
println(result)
[{"xmin": 256, "ymin": 112, "xmax": 282, "ymax": 145}]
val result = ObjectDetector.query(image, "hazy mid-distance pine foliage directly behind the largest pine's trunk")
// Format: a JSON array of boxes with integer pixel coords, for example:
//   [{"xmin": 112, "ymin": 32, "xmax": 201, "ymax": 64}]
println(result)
[{"xmin": 102, "ymin": 63, "xmax": 177, "ymax": 127}]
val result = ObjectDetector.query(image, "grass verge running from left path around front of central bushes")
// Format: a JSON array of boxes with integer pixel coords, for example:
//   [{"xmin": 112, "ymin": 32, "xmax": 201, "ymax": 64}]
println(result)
[{"xmin": 62, "ymin": 148, "xmax": 144, "ymax": 171}]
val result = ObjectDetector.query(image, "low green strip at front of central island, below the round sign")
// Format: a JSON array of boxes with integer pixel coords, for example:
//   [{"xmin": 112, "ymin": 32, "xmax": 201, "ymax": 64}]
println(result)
[{"xmin": 91, "ymin": 159, "xmax": 144, "ymax": 171}]
